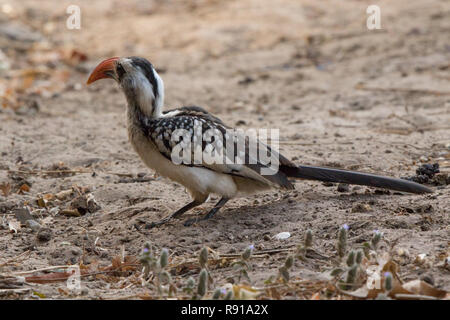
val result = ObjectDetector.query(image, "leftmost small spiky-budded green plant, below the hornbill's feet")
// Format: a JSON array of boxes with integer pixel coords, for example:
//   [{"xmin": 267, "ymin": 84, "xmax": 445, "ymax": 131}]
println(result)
[{"xmin": 140, "ymin": 242, "xmax": 176, "ymax": 297}]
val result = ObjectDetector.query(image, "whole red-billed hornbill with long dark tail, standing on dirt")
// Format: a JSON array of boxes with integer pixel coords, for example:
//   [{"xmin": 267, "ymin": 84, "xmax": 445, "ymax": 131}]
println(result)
[{"xmin": 87, "ymin": 56, "xmax": 433, "ymax": 228}]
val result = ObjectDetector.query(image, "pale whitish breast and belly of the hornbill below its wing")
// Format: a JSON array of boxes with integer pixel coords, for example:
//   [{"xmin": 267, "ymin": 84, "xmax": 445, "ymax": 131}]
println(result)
[{"xmin": 130, "ymin": 127, "xmax": 238, "ymax": 198}]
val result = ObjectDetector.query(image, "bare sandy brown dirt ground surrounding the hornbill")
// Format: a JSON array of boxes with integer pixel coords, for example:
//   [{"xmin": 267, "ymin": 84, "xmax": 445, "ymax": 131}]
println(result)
[{"xmin": 0, "ymin": 0, "xmax": 450, "ymax": 299}]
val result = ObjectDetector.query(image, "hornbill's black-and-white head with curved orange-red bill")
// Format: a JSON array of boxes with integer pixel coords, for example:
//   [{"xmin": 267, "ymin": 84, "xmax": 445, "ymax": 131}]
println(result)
[{"xmin": 87, "ymin": 57, "xmax": 164, "ymax": 117}]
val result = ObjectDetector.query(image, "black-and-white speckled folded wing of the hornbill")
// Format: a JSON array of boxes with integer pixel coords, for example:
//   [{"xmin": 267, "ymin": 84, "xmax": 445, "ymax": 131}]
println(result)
[{"xmin": 143, "ymin": 107, "xmax": 294, "ymax": 189}]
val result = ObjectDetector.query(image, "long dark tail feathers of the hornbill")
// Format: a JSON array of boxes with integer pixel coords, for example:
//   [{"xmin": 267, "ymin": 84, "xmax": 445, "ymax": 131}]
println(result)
[{"xmin": 281, "ymin": 166, "xmax": 433, "ymax": 193}]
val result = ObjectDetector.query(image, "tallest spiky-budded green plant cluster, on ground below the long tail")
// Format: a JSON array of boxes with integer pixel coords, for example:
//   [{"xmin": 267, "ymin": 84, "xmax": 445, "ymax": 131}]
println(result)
[{"xmin": 331, "ymin": 224, "xmax": 386, "ymax": 290}]
